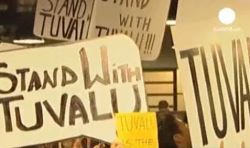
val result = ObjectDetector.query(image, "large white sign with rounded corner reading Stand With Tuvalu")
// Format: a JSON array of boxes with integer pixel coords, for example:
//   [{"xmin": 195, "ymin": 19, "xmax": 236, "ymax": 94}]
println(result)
[{"xmin": 0, "ymin": 35, "xmax": 147, "ymax": 147}]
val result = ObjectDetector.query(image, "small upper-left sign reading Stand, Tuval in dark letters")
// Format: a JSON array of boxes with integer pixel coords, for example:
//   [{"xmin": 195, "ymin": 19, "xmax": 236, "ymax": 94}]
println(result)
[{"xmin": 33, "ymin": 0, "xmax": 94, "ymax": 41}]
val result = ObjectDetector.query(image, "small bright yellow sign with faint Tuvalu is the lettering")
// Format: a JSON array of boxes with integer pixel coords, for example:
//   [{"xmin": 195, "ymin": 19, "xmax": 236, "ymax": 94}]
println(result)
[{"xmin": 115, "ymin": 112, "xmax": 158, "ymax": 148}]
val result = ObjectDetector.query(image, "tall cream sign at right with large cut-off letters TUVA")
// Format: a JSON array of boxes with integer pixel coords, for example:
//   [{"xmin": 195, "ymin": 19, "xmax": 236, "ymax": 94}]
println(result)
[{"xmin": 173, "ymin": 0, "xmax": 250, "ymax": 148}]
